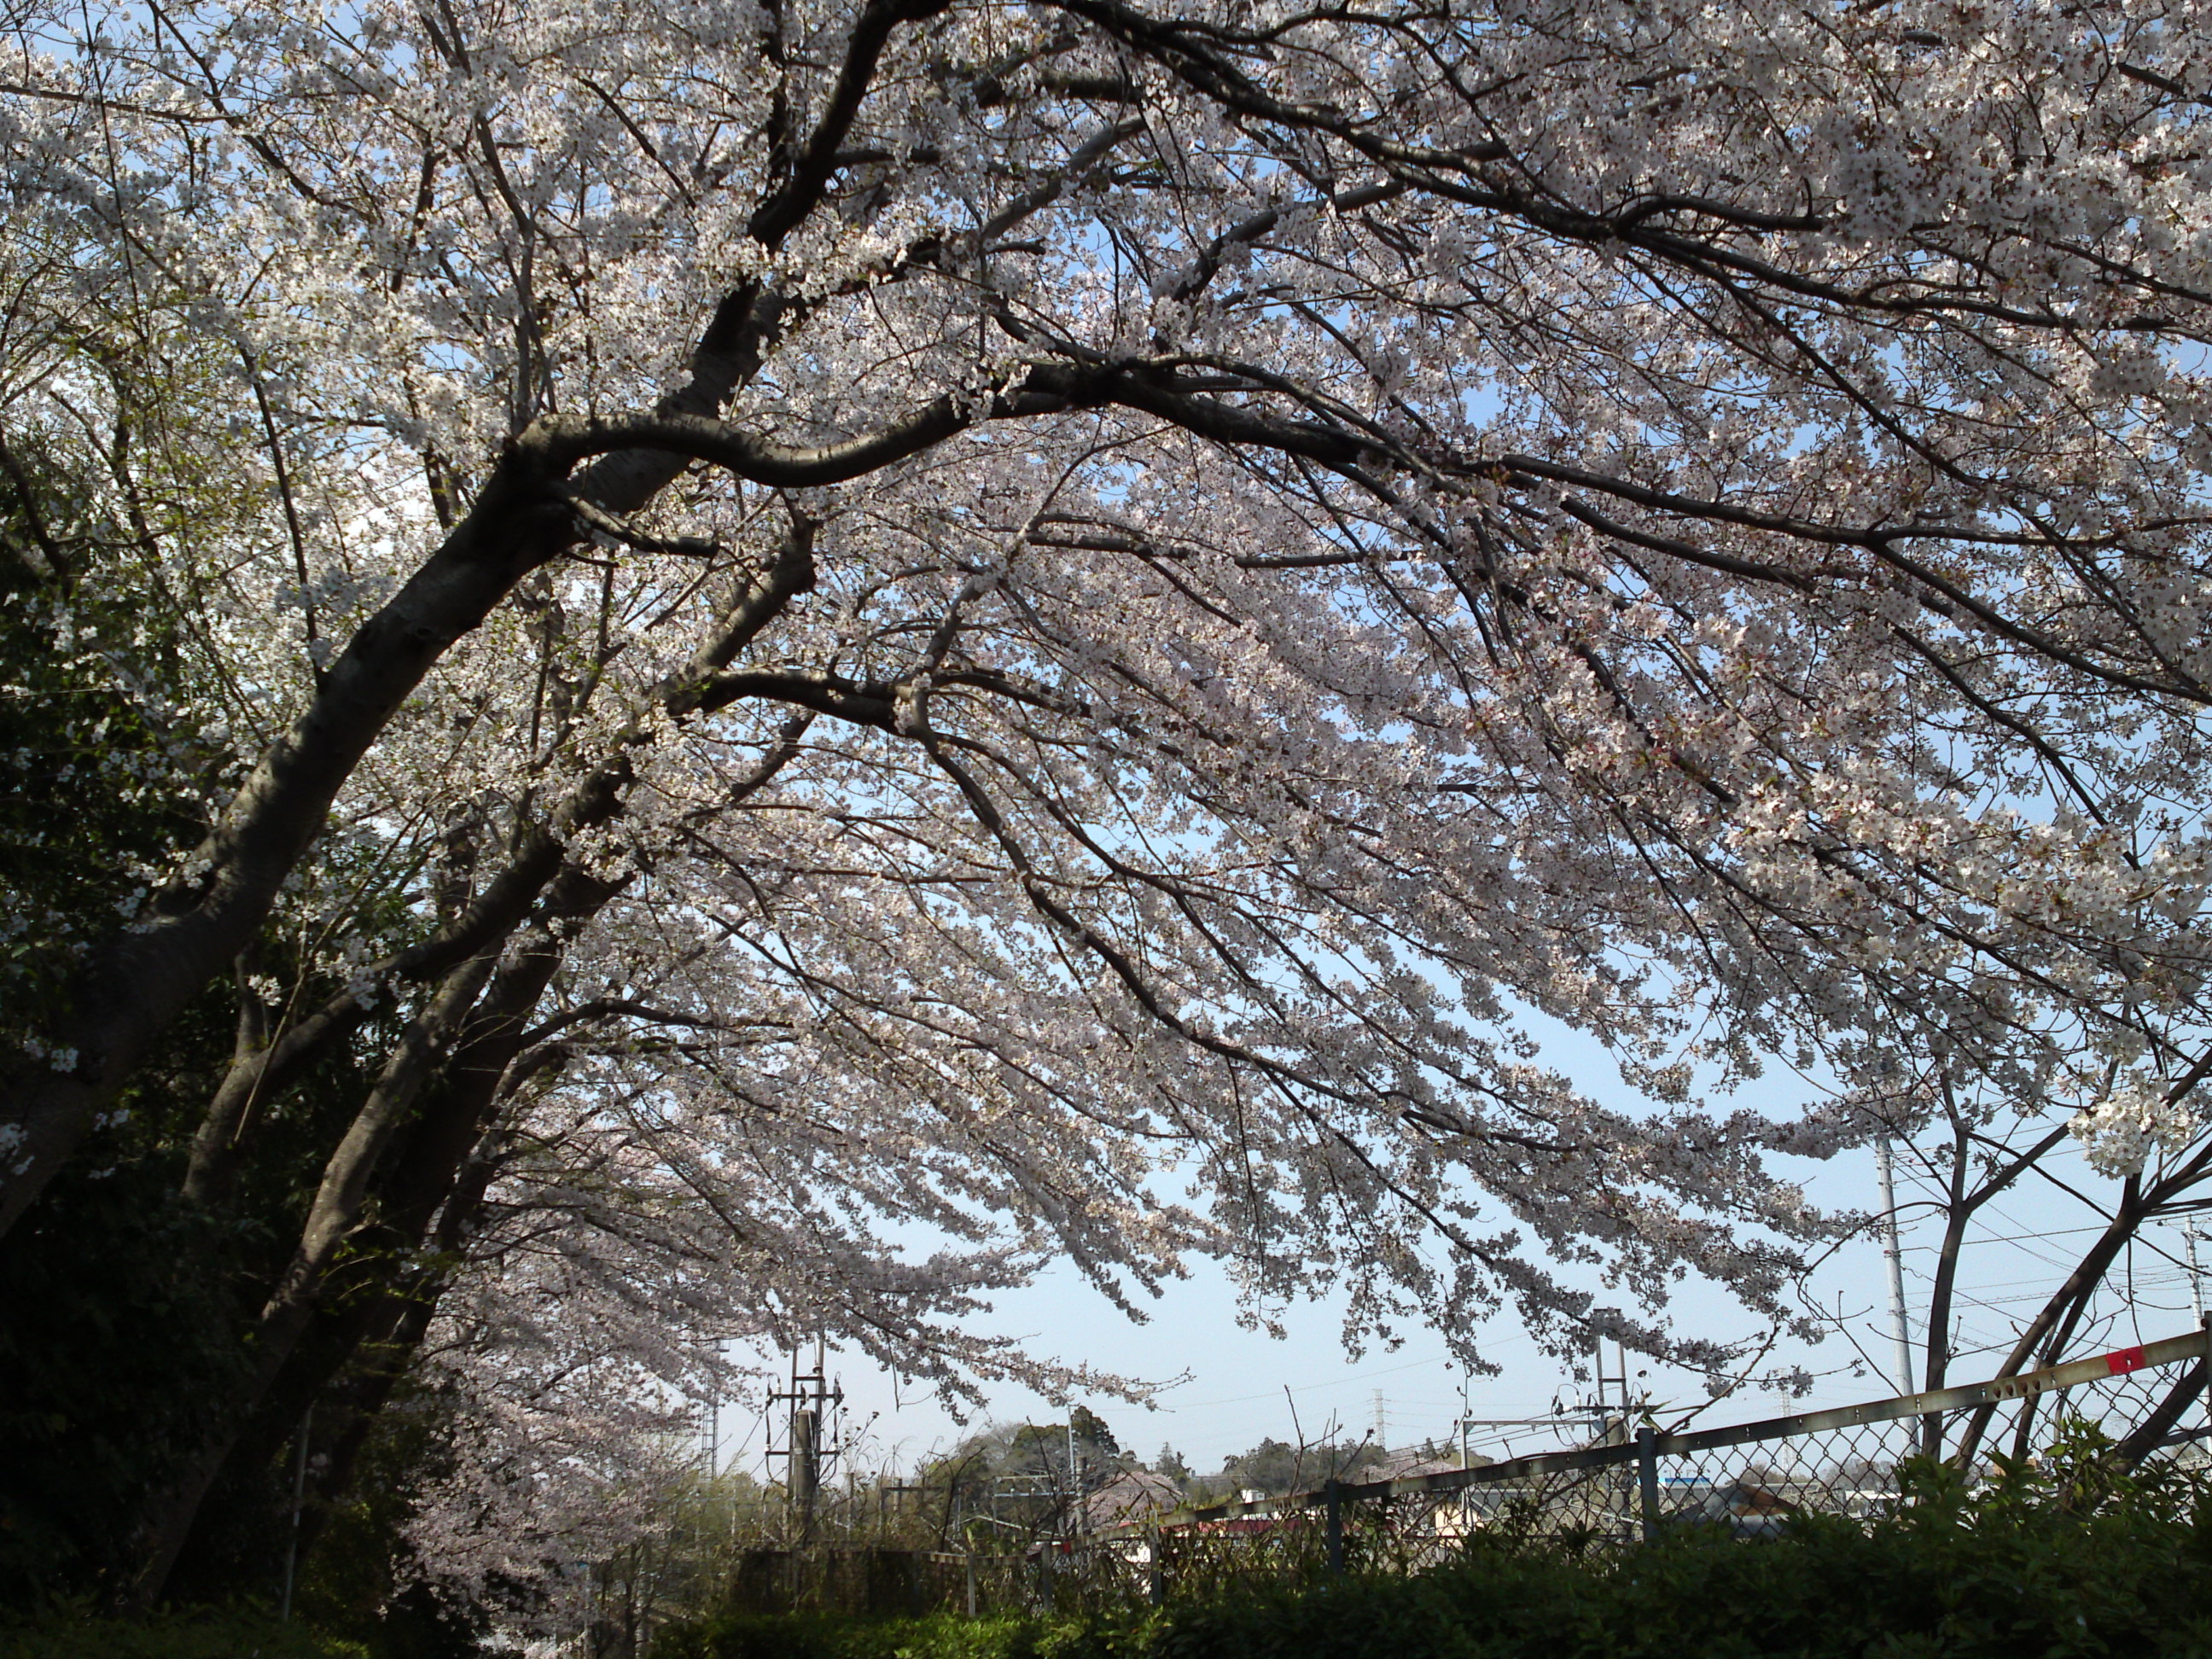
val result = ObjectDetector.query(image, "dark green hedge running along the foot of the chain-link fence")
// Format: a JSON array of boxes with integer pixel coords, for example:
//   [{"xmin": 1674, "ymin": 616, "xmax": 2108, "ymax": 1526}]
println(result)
[{"xmin": 653, "ymin": 1480, "xmax": 2212, "ymax": 1659}]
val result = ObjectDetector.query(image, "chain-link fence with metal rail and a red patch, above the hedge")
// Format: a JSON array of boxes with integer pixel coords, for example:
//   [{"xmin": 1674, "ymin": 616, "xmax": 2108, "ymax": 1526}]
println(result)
[{"xmin": 1101, "ymin": 1330, "xmax": 2212, "ymax": 1599}]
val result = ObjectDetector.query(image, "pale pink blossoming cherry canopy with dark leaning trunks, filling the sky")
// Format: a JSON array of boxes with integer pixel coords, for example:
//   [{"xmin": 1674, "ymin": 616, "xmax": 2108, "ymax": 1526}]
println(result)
[{"xmin": 0, "ymin": 0, "xmax": 2212, "ymax": 1595}]
